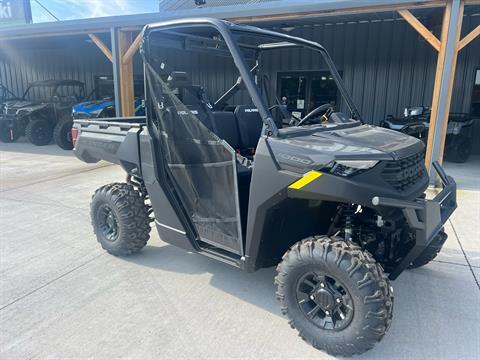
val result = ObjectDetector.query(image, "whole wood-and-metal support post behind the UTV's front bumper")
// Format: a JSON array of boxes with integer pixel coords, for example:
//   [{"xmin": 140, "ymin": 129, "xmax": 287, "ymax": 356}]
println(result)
[{"xmin": 425, "ymin": 0, "xmax": 464, "ymax": 176}]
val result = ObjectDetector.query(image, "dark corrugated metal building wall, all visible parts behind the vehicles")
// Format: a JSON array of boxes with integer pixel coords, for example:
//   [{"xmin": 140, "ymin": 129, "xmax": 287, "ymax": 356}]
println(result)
[{"xmin": 0, "ymin": 16, "xmax": 480, "ymax": 129}]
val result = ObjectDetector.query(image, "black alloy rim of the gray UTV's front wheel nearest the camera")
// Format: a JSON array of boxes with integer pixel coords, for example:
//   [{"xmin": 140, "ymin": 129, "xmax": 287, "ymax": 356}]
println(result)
[{"xmin": 296, "ymin": 271, "xmax": 354, "ymax": 331}]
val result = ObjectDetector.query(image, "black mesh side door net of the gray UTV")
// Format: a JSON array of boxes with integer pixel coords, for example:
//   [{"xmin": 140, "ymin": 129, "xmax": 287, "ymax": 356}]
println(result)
[{"xmin": 145, "ymin": 65, "xmax": 243, "ymax": 255}]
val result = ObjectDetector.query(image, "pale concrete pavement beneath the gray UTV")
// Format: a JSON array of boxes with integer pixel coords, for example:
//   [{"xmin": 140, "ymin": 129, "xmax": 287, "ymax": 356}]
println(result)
[{"xmin": 0, "ymin": 143, "xmax": 480, "ymax": 360}]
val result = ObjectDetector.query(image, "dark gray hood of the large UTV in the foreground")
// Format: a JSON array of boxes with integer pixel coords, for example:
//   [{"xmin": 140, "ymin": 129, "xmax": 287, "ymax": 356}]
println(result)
[{"xmin": 268, "ymin": 123, "xmax": 424, "ymax": 169}]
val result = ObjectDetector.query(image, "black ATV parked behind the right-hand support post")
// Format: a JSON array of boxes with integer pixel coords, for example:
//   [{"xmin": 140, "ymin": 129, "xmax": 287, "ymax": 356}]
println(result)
[{"xmin": 380, "ymin": 106, "xmax": 474, "ymax": 163}]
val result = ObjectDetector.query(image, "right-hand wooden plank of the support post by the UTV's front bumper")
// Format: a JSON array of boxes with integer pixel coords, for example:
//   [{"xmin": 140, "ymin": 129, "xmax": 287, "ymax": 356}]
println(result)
[{"xmin": 433, "ymin": 0, "xmax": 465, "ymax": 164}]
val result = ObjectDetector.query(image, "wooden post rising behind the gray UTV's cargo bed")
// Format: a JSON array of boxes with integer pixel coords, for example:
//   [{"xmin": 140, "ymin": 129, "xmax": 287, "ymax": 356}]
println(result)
[{"xmin": 117, "ymin": 31, "xmax": 135, "ymax": 116}]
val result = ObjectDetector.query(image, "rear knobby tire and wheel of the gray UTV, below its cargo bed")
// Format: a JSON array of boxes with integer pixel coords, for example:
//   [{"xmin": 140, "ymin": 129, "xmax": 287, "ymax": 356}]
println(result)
[{"xmin": 90, "ymin": 183, "xmax": 150, "ymax": 256}]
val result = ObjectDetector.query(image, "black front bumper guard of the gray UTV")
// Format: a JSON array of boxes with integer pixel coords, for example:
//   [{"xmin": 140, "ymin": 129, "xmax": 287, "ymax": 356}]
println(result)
[{"xmin": 372, "ymin": 162, "xmax": 457, "ymax": 280}]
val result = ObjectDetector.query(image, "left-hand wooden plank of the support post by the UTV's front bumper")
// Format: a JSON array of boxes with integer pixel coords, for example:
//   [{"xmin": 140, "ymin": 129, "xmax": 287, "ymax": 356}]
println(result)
[{"xmin": 425, "ymin": 2, "xmax": 452, "ymax": 171}]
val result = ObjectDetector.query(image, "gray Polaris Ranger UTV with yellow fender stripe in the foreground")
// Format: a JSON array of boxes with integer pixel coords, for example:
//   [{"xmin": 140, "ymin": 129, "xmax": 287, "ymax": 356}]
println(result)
[{"xmin": 72, "ymin": 19, "xmax": 456, "ymax": 355}]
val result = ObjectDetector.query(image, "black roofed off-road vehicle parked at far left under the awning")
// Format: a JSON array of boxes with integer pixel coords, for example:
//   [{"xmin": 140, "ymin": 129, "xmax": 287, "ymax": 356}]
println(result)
[{"xmin": 0, "ymin": 80, "xmax": 85, "ymax": 150}]
